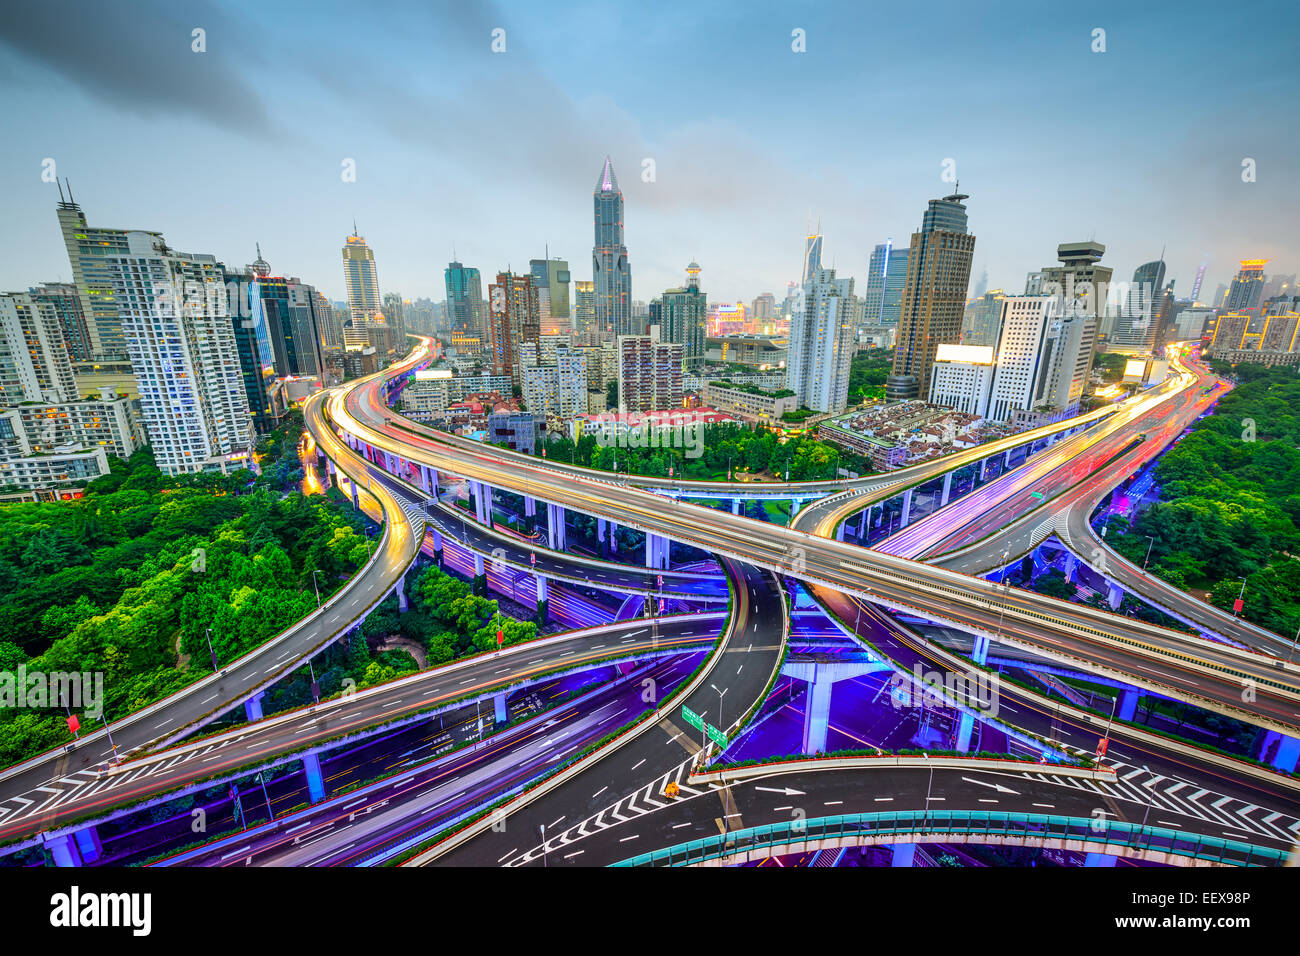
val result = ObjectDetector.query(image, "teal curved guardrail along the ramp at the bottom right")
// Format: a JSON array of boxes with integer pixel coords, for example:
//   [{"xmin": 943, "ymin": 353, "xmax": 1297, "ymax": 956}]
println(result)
[{"xmin": 614, "ymin": 810, "xmax": 1287, "ymax": 866}]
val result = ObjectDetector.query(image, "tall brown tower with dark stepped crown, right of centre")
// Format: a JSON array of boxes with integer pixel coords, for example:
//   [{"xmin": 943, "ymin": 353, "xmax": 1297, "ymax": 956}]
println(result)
[{"xmin": 885, "ymin": 193, "xmax": 975, "ymax": 402}]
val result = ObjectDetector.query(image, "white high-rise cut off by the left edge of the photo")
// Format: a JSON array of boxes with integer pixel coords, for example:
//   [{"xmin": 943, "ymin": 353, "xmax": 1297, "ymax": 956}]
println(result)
[{"xmin": 0, "ymin": 293, "xmax": 78, "ymax": 405}]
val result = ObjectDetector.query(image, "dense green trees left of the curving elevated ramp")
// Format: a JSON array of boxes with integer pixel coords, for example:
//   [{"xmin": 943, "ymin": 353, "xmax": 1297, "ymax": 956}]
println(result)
[{"xmin": 0, "ymin": 420, "xmax": 377, "ymax": 766}]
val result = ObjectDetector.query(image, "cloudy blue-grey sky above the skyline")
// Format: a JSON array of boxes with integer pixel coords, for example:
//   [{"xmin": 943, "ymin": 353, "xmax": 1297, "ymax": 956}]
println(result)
[{"xmin": 0, "ymin": 0, "xmax": 1300, "ymax": 302}]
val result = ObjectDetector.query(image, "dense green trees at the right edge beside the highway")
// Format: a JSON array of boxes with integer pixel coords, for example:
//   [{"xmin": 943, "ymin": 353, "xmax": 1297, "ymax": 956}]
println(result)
[{"xmin": 1106, "ymin": 364, "xmax": 1300, "ymax": 636}]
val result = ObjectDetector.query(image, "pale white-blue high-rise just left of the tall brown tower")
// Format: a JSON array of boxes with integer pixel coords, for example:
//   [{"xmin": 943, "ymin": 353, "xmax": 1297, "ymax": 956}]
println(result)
[{"xmin": 785, "ymin": 269, "xmax": 854, "ymax": 415}]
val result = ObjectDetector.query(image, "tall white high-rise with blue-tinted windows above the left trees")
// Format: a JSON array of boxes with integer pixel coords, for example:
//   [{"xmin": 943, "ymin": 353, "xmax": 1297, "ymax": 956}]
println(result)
[{"xmin": 108, "ymin": 233, "xmax": 252, "ymax": 475}]
